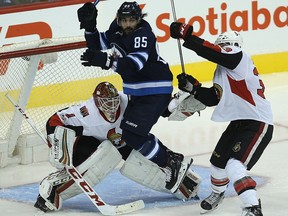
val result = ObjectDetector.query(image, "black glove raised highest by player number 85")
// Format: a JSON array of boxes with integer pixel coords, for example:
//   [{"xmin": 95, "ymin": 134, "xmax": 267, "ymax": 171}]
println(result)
[{"xmin": 77, "ymin": 2, "xmax": 98, "ymax": 32}]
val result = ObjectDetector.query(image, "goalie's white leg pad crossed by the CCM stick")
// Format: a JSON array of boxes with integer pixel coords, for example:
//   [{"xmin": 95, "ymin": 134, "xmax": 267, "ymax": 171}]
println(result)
[{"xmin": 36, "ymin": 140, "xmax": 122, "ymax": 210}]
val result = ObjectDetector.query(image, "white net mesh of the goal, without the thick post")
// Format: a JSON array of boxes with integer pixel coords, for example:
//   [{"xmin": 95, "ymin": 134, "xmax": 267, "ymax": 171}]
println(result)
[{"xmin": 0, "ymin": 37, "xmax": 122, "ymax": 140}]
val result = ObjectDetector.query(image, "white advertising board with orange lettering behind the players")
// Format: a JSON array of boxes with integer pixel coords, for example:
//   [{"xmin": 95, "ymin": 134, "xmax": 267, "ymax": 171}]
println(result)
[{"xmin": 0, "ymin": 0, "xmax": 288, "ymax": 60}]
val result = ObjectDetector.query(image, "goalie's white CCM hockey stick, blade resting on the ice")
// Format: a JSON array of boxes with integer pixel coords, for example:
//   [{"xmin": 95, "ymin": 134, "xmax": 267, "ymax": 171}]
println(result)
[{"xmin": 5, "ymin": 93, "xmax": 145, "ymax": 215}]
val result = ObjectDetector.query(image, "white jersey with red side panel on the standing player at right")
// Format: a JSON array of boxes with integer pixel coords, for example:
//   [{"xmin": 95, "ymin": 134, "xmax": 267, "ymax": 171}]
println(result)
[{"xmin": 211, "ymin": 46, "xmax": 273, "ymax": 125}]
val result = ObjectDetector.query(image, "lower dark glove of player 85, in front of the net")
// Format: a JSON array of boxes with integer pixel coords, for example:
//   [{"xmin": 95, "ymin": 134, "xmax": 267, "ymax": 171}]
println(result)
[{"xmin": 81, "ymin": 49, "xmax": 114, "ymax": 70}]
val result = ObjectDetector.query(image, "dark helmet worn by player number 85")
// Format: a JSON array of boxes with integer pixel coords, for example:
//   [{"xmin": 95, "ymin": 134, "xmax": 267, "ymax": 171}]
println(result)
[{"xmin": 117, "ymin": 1, "xmax": 144, "ymax": 23}]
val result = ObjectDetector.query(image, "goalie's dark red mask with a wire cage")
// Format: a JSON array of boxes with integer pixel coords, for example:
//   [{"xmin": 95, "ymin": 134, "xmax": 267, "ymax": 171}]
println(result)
[{"xmin": 93, "ymin": 82, "xmax": 120, "ymax": 122}]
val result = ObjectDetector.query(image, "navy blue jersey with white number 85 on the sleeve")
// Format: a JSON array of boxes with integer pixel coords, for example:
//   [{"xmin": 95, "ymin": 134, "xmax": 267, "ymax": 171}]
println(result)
[{"xmin": 85, "ymin": 19, "xmax": 173, "ymax": 96}]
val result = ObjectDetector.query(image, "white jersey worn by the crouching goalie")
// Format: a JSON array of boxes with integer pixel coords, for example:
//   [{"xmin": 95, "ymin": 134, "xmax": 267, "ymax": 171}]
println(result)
[{"xmin": 57, "ymin": 92, "xmax": 128, "ymax": 145}]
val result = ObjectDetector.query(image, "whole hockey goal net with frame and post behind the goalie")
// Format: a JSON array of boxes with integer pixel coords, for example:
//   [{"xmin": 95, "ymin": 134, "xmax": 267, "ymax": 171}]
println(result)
[{"xmin": 0, "ymin": 37, "xmax": 122, "ymax": 167}]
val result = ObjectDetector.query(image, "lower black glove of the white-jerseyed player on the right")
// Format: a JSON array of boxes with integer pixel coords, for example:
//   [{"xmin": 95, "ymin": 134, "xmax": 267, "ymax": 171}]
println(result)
[{"xmin": 177, "ymin": 73, "xmax": 201, "ymax": 95}]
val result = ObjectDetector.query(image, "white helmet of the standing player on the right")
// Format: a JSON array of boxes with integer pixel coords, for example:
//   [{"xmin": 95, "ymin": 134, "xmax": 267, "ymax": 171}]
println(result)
[{"xmin": 215, "ymin": 31, "xmax": 243, "ymax": 48}]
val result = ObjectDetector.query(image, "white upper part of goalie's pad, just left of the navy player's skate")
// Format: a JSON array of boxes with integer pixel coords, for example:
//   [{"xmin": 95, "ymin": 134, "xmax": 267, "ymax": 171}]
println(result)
[{"xmin": 120, "ymin": 150, "xmax": 169, "ymax": 192}]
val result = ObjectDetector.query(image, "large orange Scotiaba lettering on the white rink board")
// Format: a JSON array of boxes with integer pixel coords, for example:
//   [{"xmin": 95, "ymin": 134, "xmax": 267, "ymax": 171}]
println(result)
[{"xmin": 156, "ymin": 1, "xmax": 288, "ymax": 42}]
